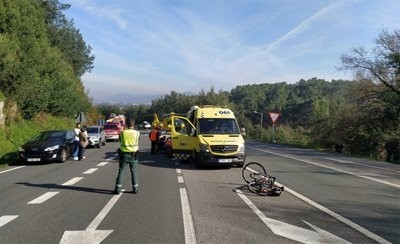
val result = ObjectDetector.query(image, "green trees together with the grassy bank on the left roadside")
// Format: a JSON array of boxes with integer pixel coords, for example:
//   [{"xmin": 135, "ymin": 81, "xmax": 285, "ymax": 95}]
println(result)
[{"xmin": 0, "ymin": 0, "xmax": 95, "ymax": 164}]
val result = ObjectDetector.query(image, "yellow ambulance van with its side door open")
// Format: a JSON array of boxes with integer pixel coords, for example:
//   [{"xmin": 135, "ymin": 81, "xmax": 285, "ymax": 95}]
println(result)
[{"xmin": 153, "ymin": 105, "xmax": 246, "ymax": 167}]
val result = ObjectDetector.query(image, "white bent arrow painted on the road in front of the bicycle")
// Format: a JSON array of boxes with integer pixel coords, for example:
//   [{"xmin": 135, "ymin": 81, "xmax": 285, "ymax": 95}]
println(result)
[{"xmin": 236, "ymin": 189, "xmax": 350, "ymax": 244}]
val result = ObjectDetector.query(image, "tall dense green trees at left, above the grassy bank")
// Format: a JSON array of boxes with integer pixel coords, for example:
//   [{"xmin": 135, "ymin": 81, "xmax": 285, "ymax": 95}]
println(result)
[{"xmin": 0, "ymin": 0, "xmax": 94, "ymax": 119}]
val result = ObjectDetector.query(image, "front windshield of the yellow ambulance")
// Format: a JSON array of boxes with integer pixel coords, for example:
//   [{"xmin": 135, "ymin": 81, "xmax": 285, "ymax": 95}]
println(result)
[{"xmin": 199, "ymin": 119, "xmax": 239, "ymax": 134}]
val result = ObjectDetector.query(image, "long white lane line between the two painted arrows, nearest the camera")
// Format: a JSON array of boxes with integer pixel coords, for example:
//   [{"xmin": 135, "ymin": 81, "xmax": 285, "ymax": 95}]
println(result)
[{"xmin": 179, "ymin": 188, "xmax": 197, "ymax": 244}]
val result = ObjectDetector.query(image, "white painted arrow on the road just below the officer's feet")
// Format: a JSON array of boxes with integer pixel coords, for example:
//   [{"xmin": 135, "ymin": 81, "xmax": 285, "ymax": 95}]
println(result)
[{"xmin": 60, "ymin": 189, "xmax": 125, "ymax": 244}]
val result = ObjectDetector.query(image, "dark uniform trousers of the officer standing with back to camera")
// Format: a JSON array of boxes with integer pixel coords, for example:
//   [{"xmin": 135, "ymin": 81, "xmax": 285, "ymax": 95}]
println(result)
[{"xmin": 115, "ymin": 152, "xmax": 139, "ymax": 192}]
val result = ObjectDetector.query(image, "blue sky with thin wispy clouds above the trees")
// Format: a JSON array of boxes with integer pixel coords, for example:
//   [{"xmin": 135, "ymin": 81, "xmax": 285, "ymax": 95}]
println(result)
[{"xmin": 61, "ymin": 0, "xmax": 400, "ymax": 101}]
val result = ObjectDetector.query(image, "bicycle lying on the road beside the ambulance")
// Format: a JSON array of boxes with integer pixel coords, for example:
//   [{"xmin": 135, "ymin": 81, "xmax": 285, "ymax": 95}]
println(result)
[{"xmin": 242, "ymin": 162, "xmax": 284, "ymax": 196}]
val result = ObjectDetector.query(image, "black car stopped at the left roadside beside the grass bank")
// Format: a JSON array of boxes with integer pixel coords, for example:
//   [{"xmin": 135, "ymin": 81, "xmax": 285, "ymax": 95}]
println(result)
[{"xmin": 18, "ymin": 130, "xmax": 75, "ymax": 162}]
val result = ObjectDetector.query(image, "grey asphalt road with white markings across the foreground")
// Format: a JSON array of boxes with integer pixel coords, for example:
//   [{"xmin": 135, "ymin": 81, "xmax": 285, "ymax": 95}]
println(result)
[{"xmin": 0, "ymin": 135, "xmax": 400, "ymax": 243}]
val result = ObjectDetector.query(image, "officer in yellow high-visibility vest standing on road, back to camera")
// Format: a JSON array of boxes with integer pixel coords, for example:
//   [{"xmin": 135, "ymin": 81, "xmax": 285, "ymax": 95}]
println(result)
[{"xmin": 114, "ymin": 120, "xmax": 140, "ymax": 194}]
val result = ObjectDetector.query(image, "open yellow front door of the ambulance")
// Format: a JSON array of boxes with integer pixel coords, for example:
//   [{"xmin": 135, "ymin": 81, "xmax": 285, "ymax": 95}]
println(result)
[{"xmin": 171, "ymin": 116, "xmax": 198, "ymax": 159}]
